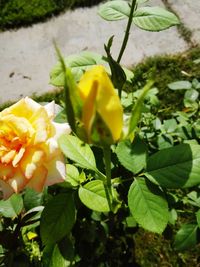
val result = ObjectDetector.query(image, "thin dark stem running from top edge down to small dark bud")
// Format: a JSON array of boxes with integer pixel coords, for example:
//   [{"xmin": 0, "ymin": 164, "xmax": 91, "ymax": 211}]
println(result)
[{"xmin": 117, "ymin": 0, "xmax": 136, "ymax": 63}]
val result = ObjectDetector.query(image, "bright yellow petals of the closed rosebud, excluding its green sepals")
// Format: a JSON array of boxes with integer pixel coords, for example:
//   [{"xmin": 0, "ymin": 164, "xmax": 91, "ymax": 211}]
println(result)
[{"xmin": 78, "ymin": 66, "xmax": 123, "ymax": 141}]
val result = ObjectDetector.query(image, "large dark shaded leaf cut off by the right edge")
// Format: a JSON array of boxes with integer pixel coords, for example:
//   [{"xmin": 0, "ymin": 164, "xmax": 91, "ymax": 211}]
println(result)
[{"xmin": 145, "ymin": 144, "xmax": 200, "ymax": 188}]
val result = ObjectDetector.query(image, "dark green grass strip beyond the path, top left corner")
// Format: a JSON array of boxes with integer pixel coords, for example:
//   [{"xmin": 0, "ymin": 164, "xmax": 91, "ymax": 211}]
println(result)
[{"xmin": 0, "ymin": 0, "xmax": 101, "ymax": 29}]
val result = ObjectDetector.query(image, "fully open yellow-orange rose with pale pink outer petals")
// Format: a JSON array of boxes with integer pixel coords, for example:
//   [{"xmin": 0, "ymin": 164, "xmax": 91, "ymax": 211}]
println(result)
[{"xmin": 0, "ymin": 97, "xmax": 70, "ymax": 199}]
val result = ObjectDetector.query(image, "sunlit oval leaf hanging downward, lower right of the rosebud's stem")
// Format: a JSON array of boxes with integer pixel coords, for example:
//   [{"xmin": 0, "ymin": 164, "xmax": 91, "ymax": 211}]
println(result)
[{"xmin": 128, "ymin": 178, "xmax": 169, "ymax": 233}]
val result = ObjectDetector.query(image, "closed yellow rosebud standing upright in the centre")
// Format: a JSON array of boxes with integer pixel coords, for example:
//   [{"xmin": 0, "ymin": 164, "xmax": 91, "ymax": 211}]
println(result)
[{"xmin": 78, "ymin": 66, "xmax": 123, "ymax": 143}]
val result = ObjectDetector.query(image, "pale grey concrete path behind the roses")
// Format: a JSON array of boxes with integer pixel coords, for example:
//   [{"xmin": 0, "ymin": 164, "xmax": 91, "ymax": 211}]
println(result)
[{"xmin": 0, "ymin": 0, "xmax": 200, "ymax": 103}]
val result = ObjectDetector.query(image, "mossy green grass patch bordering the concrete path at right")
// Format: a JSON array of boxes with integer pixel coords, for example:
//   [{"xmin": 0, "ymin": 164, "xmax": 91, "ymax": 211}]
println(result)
[{"xmin": 132, "ymin": 47, "xmax": 200, "ymax": 117}]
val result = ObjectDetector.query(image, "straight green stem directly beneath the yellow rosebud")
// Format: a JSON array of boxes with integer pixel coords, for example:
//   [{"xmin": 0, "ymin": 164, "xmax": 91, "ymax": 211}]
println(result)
[{"xmin": 103, "ymin": 146, "xmax": 113, "ymax": 211}]
